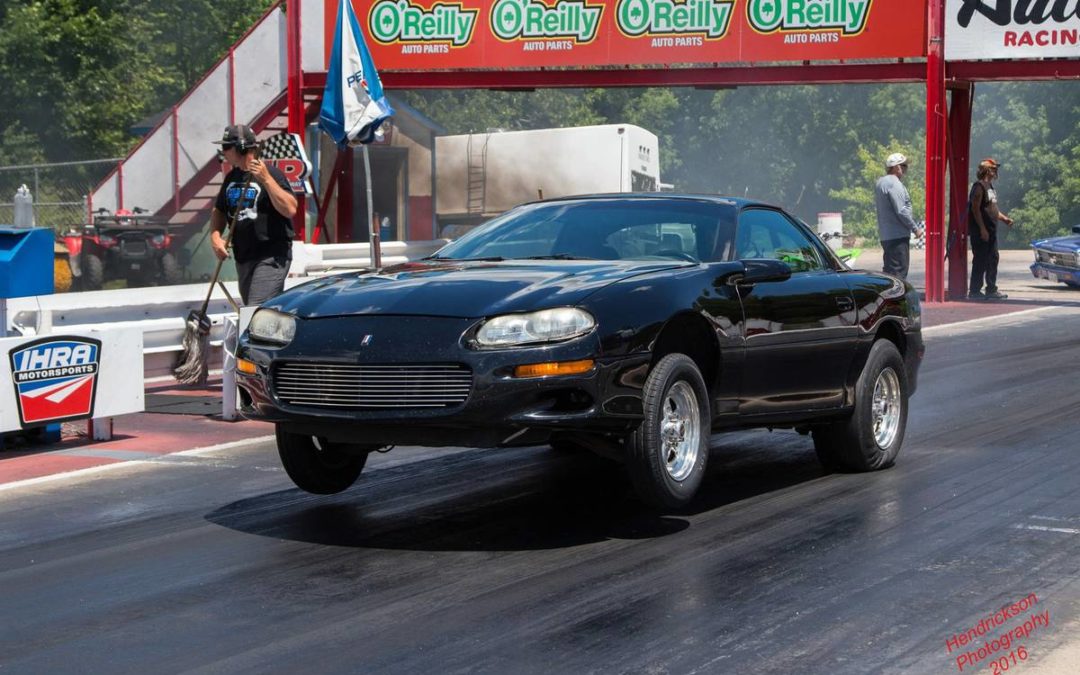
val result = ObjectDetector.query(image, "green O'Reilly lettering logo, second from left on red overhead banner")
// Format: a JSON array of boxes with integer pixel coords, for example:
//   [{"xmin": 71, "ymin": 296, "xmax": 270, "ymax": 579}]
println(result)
[{"xmin": 491, "ymin": 0, "xmax": 604, "ymax": 43}]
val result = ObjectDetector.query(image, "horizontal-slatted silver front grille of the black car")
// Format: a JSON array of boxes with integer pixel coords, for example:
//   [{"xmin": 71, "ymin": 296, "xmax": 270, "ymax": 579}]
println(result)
[{"xmin": 271, "ymin": 362, "xmax": 472, "ymax": 409}]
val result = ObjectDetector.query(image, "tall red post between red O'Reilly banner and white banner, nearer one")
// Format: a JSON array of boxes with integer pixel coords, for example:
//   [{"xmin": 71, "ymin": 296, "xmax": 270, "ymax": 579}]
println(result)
[{"xmin": 926, "ymin": 0, "xmax": 947, "ymax": 302}]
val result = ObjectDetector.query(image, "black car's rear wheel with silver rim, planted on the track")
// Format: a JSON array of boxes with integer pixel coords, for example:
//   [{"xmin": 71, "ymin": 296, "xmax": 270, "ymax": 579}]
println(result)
[{"xmin": 813, "ymin": 340, "xmax": 909, "ymax": 472}]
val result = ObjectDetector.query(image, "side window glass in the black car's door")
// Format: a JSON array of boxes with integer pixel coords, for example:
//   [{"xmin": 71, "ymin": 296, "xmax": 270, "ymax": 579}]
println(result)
[{"xmin": 735, "ymin": 208, "xmax": 824, "ymax": 272}]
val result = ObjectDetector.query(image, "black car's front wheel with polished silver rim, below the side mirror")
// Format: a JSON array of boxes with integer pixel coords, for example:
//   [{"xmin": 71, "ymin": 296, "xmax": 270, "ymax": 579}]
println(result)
[{"xmin": 626, "ymin": 354, "xmax": 712, "ymax": 509}]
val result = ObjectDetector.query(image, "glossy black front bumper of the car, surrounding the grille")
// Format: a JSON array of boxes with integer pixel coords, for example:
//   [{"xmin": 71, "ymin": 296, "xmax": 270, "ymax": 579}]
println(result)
[{"xmin": 237, "ymin": 318, "xmax": 650, "ymax": 447}]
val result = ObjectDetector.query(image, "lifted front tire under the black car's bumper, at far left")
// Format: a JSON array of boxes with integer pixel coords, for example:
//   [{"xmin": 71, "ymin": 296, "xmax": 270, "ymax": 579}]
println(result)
[{"xmin": 275, "ymin": 424, "xmax": 377, "ymax": 495}]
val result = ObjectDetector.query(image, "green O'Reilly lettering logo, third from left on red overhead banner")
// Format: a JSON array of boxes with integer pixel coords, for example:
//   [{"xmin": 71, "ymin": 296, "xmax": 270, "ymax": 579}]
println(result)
[{"xmin": 616, "ymin": 0, "xmax": 734, "ymax": 40}]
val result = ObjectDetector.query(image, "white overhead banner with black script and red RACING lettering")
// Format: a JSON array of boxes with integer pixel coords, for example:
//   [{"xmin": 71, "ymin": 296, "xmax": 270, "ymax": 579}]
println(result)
[{"xmin": 945, "ymin": 0, "xmax": 1080, "ymax": 60}]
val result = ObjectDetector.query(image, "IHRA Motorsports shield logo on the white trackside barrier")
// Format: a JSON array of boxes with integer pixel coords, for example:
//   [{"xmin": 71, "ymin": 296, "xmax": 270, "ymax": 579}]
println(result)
[{"xmin": 11, "ymin": 337, "xmax": 102, "ymax": 427}]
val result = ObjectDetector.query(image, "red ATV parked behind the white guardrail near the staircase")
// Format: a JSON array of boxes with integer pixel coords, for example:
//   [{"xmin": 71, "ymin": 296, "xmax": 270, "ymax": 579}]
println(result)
[{"xmin": 78, "ymin": 206, "xmax": 183, "ymax": 291}]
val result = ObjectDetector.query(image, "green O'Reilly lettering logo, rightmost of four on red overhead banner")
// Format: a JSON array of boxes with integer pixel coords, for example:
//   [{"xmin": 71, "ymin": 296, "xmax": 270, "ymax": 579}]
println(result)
[{"xmin": 746, "ymin": 0, "xmax": 872, "ymax": 36}]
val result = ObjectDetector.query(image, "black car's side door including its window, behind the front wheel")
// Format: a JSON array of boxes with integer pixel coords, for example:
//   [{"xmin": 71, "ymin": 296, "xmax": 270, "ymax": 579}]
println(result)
[{"xmin": 734, "ymin": 207, "xmax": 858, "ymax": 415}]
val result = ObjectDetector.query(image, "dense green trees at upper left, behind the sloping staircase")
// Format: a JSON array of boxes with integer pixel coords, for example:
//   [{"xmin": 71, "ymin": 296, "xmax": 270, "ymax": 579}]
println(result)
[{"xmin": 0, "ymin": 0, "xmax": 271, "ymax": 163}]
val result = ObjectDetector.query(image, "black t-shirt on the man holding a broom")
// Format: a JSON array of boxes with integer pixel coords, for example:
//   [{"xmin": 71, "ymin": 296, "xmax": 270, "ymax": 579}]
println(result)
[{"xmin": 214, "ymin": 165, "xmax": 294, "ymax": 262}]
